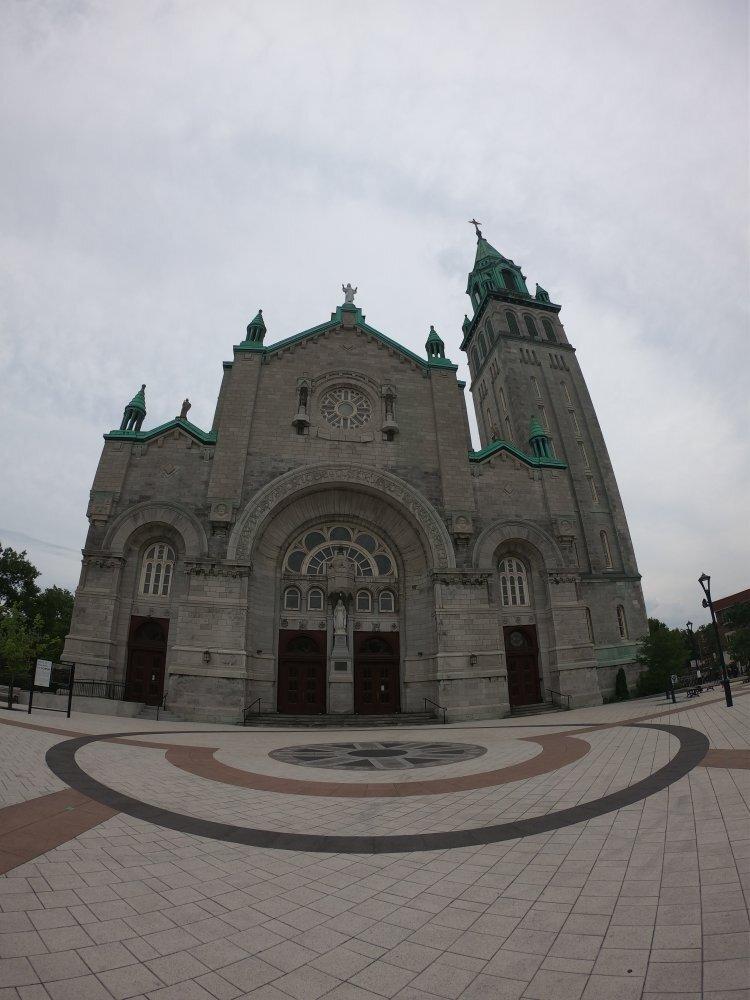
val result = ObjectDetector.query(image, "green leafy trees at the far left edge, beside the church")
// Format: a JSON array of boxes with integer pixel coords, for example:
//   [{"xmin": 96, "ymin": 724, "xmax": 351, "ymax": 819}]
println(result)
[{"xmin": 0, "ymin": 545, "xmax": 73, "ymax": 676}]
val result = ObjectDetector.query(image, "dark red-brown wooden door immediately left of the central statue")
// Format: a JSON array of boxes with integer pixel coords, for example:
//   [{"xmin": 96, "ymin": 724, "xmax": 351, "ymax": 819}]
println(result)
[{"xmin": 278, "ymin": 629, "xmax": 326, "ymax": 715}]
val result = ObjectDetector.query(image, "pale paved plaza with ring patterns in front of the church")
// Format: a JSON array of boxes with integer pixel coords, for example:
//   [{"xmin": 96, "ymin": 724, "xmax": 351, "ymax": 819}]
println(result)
[{"xmin": 0, "ymin": 686, "xmax": 750, "ymax": 1000}]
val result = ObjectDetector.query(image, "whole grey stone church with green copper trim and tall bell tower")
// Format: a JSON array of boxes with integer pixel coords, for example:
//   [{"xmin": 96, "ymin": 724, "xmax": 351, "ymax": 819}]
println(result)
[{"xmin": 64, "ymin": 229, "xmax": 647, "ymax": 722}]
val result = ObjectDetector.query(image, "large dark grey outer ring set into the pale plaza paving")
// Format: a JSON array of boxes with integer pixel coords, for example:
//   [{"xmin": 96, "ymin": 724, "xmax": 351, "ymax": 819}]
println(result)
[{"xmin": 46, "ymin": 723, "xmax": 709, "ymax": 854}]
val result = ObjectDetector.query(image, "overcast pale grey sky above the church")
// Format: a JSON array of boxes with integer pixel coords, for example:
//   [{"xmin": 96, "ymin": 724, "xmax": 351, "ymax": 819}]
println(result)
[{"xmin": 0, "ymin": 0, "xmax": 750, "ymax": 625}]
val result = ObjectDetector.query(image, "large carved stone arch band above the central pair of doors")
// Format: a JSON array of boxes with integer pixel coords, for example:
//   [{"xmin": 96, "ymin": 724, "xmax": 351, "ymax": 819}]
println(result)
[{"xmin": 227, "ymin": 462, "xmax": 456, "ymax": 569}]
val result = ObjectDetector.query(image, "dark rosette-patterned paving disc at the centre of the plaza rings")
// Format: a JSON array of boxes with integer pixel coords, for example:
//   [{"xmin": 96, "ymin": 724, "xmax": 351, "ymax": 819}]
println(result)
[{"xmin": 268, "ymin": 740, "xmax": 487, "ymax": 771}]
